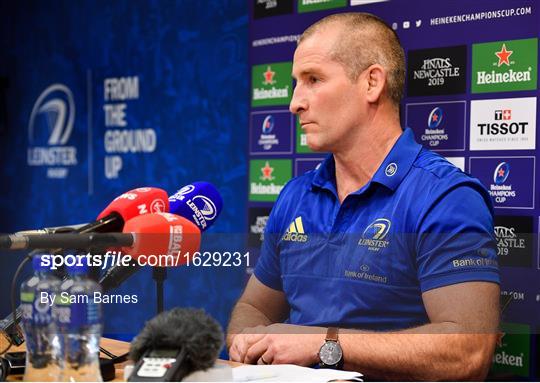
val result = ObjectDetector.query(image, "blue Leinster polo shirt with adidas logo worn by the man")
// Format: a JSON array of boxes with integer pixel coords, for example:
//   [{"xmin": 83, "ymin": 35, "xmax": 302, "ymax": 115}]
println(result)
[{"xmin": 254, "ymin": 129, "xmax": 500, "ymax": 330}]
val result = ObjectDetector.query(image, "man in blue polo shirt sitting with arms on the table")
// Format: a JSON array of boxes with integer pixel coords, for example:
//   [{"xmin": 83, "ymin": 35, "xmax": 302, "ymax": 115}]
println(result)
[{"xmin": 227, "ymin": 13, "xmax": 499, "ymax": 380}]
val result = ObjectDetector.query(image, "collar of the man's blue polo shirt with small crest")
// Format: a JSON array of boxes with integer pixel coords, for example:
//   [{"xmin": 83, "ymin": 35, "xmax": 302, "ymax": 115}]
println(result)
[{"xmin": 311, "ymin": 128, "xmax": 422, "ymax": 194}]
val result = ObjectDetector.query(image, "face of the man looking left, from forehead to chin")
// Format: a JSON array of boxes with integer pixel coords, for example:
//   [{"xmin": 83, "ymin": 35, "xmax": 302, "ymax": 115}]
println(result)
[{"xmin": 289, "ymin": 26, "xmax": 365, "ymax": 153}]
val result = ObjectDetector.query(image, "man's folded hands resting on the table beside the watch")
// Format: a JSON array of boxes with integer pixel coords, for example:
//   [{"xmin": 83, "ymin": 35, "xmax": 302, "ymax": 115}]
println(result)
[{"xmin": 229, "ymin": 323, "xmax": 326, "ymax": 366}]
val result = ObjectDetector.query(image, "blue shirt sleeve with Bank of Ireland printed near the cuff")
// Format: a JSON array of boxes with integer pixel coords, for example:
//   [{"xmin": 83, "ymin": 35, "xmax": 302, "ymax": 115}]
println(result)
[{"xmin": 416, "ymin": 182, "xmax": 500, "ymax": 292}]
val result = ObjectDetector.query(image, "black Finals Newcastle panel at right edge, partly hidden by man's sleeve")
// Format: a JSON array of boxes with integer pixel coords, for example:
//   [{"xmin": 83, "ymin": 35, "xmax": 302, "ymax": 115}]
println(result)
[{"xmin": 494, "ymin": 215, "xmax": 535, "ymax": 267}]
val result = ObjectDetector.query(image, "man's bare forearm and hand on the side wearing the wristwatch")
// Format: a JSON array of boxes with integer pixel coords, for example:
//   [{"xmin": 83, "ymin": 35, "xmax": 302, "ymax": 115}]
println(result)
[{"xmin": 243, "ymin": 282, "xmax": 499, "ymax": 380}]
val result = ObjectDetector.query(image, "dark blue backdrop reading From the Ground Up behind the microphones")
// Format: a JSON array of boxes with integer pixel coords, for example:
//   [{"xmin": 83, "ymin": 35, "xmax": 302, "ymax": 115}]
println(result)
[{"xmin": 0, "ymin": 0, "xmax": 249, "ymax": 356}]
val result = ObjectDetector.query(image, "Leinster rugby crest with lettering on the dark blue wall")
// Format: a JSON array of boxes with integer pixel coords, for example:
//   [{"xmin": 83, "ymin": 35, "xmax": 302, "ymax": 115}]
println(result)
[{"xmin": 27, "ymin": 84, "xmax": 78, "ymax": 178}]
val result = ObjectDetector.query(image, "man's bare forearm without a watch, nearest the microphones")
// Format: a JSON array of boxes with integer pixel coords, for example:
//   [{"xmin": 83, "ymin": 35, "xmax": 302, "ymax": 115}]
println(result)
[{"xmin": 227, "ymin": 275, "xmax": 289, "ymax": 361}]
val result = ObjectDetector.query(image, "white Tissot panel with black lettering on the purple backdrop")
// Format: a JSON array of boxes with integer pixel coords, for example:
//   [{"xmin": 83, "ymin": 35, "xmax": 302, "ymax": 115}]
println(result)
[{"xmin": 470, "ymin": 97, "xmax": 536, "ymax": 150}]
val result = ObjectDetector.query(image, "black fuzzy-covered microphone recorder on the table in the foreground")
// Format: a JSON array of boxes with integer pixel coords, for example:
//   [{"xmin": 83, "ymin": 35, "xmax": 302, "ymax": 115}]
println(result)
[{"xmin": 128, "ymin": 308, "xmax": 223, "ymax": 382}]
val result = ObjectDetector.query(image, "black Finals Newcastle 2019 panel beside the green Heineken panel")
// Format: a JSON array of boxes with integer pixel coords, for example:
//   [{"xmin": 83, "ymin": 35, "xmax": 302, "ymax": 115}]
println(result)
[{"xmin": 407, "ymin": 45, "xmax": 467, "ymax": 96}]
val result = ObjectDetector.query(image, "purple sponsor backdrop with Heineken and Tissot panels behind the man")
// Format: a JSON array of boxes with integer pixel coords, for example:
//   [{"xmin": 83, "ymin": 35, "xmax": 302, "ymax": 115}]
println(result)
[{"xmin": 247, "ymin": 0, "xmax": 540, "ymax": 378}]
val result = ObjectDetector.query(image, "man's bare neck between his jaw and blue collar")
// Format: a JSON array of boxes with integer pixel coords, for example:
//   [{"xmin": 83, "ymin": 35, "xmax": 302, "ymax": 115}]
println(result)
[{"xmin": 334, "ymin": 121, "xmax": 402, "ymax": 203}]
